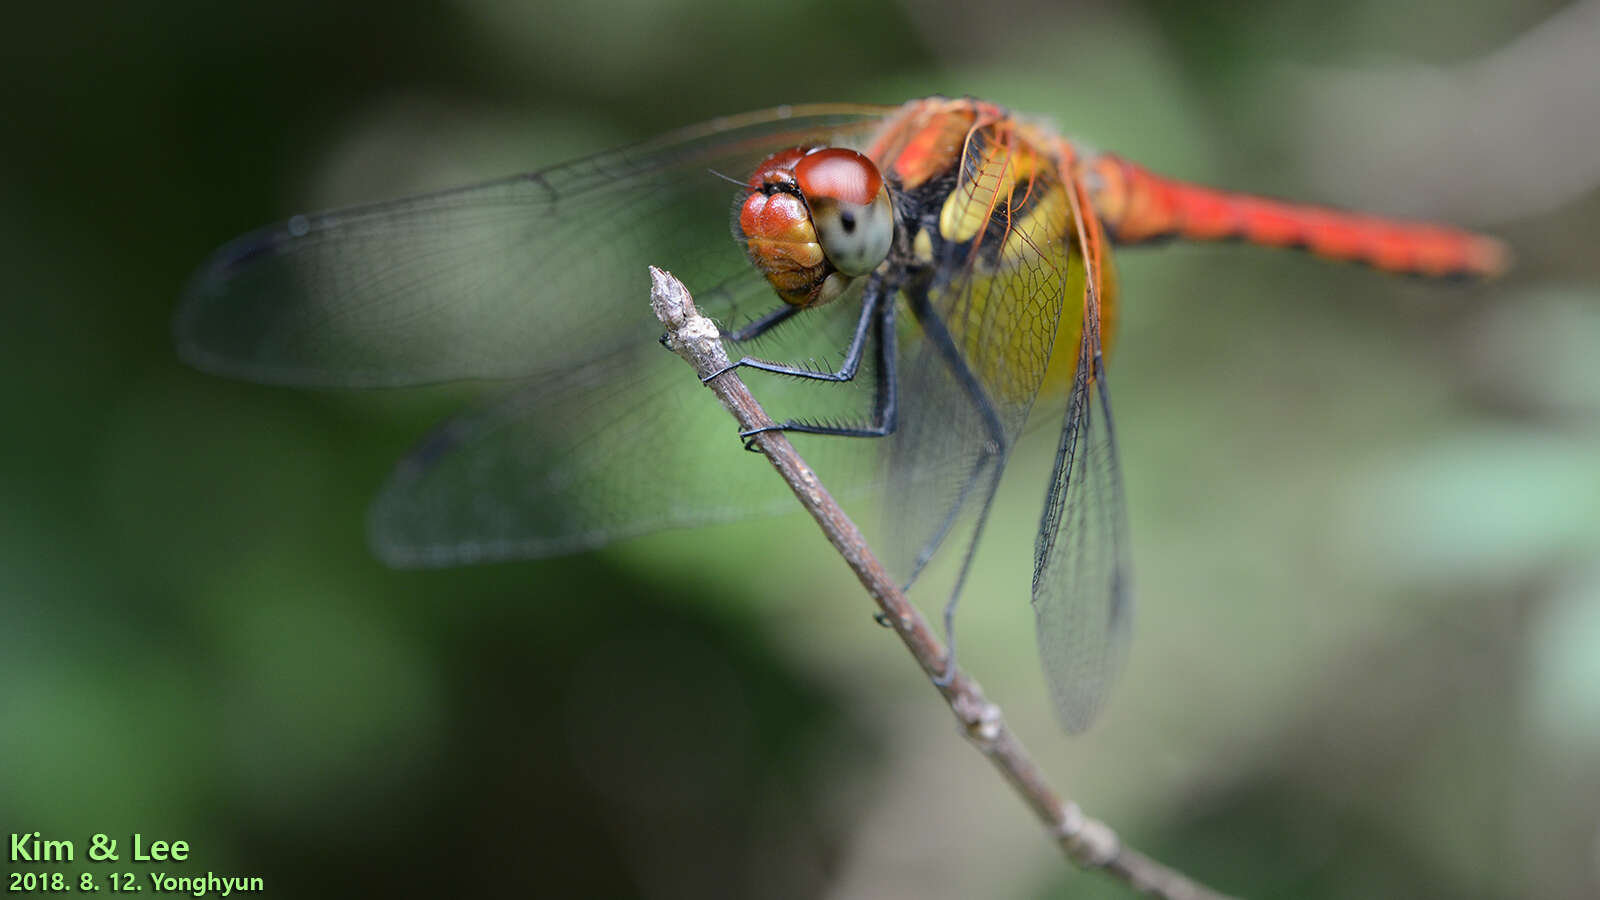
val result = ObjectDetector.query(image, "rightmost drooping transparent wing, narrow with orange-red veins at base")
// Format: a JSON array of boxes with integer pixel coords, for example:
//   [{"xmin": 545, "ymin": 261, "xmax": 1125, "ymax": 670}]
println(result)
[{"xmin": 1034, "ymin": 171, "xmax": 1133, "ymax": 733}]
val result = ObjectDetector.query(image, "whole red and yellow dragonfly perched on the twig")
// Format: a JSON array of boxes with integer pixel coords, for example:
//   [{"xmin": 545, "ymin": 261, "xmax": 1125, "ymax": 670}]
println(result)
[{"xmin": 174, "ymin": 96, "xmax": 1509, "ymax": 732}]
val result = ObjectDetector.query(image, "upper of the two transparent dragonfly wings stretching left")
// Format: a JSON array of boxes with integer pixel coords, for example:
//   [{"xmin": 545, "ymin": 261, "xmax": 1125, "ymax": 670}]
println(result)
[{"xmin": 174, "ymin": 106, "xmax": 885, "ymax": 388}]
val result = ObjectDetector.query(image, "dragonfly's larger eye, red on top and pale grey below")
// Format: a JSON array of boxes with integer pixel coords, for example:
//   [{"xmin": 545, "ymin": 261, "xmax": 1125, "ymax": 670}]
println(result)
[{"xmin": 794, "ymin": 147, "xmax": 894, "ymax": 277}]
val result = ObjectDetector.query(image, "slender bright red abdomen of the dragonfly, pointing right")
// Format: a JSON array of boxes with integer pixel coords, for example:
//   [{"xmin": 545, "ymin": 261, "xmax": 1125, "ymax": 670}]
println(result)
[{"xmin": 1086, "ymin": 155, "xmax": 1509, "ymax": 277}]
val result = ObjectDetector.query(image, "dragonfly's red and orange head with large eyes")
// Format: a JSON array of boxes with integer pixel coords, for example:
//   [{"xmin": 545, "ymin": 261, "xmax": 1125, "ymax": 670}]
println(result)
[{"xmin": 739, "ymin": 147, "xmax": 894, "ymax": 306}]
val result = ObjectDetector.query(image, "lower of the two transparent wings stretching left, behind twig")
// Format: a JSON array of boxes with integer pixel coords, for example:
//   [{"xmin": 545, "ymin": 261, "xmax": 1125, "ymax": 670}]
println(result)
[{"xmin": 368, "ymin": 272, "xmax": 880, "ymax": 565}]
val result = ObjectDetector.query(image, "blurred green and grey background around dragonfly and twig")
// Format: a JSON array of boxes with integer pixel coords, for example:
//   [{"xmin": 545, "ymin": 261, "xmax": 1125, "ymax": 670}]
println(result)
[{"xmin": 0, "ymin": 0, "xmax": 1600, "ymax": 898}]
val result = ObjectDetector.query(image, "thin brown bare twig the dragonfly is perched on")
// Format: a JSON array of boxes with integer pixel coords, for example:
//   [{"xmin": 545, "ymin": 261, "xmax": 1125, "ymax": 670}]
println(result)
[{"xmin": 650, "ymin": 266, "xmax": 1226, "ymax": 900}]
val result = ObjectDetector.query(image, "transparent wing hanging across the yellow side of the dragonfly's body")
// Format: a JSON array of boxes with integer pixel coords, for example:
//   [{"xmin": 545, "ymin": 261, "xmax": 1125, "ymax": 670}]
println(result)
[{"xmin": 885, "ymin": 115, "xmax": 1082, "ymax": 581}]
